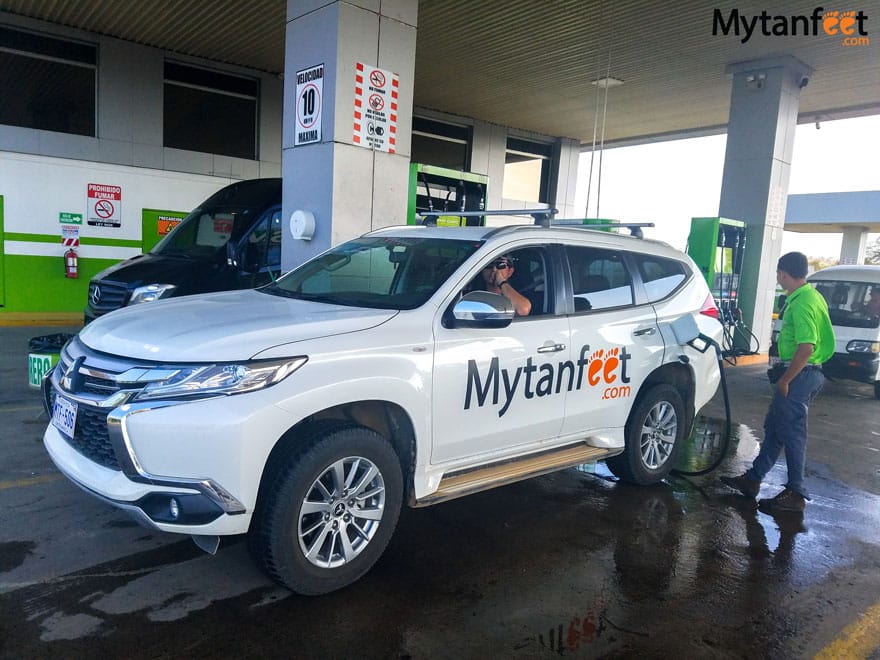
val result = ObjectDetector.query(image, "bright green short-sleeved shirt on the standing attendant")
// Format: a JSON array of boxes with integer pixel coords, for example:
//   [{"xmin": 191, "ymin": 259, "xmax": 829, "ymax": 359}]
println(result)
[{"xmin": 777, "ymin": 284, "xmax": 834, "ymax": 364}]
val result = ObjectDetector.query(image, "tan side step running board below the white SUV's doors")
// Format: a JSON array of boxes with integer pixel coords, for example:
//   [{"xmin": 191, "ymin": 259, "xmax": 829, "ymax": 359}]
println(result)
[{"xmin": 414, "ymin": 444, "xmax": 623, "ymax": 507}]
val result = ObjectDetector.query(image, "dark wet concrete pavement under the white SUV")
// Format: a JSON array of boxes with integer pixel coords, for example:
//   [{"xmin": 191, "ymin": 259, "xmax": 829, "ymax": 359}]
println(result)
[{"xmin": 0, "ymin": 328, "xmax": 880, "ymax": 659}]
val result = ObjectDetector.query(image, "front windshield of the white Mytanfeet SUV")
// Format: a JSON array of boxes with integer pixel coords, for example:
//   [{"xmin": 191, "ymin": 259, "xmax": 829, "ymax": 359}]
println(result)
[{"xmin": 260, "ymin": 236, "xmax": 482, "ymax": 309}]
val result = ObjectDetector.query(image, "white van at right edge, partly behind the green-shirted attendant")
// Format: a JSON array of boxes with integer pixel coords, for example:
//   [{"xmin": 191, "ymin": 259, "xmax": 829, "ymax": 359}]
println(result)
[{"xmin": 773, "ymin": 266, "xmax": 880, "ymax": 399}]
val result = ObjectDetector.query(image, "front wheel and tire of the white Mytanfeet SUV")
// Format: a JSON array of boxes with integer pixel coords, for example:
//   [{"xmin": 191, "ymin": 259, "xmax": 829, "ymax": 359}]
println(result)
[{"xmin": 250, "ymin": 425, "xmax": 403, "ymax": 596}]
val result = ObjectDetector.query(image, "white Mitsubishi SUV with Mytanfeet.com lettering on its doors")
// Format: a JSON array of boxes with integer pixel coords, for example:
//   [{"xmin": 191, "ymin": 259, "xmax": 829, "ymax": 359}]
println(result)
[{"xmin": 44, "ymin": 220, "xmax": 721, "ymax": 594}]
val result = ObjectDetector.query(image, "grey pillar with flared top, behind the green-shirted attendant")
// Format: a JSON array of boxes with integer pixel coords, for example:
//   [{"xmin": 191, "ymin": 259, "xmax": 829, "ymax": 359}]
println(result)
[{"xmin": 718, "ymin": 56, "xmax": 812, "ymax": 350}]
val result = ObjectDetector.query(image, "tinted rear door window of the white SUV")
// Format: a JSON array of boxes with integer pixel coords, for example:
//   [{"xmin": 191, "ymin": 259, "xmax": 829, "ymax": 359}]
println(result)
[{"xmin": 565, "ymin": 245, "xmax": 633, "ymax": 312}]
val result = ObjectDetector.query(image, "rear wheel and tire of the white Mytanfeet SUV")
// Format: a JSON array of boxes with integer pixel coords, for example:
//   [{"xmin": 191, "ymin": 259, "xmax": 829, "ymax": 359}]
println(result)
[{"xmin": 606, "ymin": 383, "xmax": 685, "ymax": 486}]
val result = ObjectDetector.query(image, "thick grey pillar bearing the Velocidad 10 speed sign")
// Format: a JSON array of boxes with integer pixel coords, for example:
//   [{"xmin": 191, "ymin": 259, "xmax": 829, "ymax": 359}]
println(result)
[{"xmin": 281, "ymin": 0, "xmax": 418, "ymax": 270}]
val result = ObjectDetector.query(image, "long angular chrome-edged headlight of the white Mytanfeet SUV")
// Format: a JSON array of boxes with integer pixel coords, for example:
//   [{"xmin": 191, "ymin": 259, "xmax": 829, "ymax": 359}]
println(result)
[{"xmin": 134, "ymin": 356, "xmax": 308, "ymax": 401}]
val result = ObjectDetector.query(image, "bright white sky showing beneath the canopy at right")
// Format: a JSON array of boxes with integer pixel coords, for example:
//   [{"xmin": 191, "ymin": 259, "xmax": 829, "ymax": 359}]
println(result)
[{"xmin": 575, "ymin": 115, "xmax": 880, "ymax": 259}]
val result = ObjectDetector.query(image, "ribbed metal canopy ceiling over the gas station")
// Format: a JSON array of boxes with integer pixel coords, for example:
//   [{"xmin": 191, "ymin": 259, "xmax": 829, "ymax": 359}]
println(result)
[{"xmin": 0, "ymin": 0, "xmax": 880, "ymax": 148}]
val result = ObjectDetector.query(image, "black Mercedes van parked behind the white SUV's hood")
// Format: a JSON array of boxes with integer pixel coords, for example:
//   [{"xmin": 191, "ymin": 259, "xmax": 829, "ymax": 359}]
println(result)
[{"xmin": 85, "ymin": 179, "xmax": 281, "ymax": 323}]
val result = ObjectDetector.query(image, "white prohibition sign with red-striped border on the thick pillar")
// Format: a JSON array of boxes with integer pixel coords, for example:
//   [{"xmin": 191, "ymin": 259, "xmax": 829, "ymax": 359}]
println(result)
[{"xmin": 354, "ymin": 62, "xmax": 400, "ymax": 154}]
